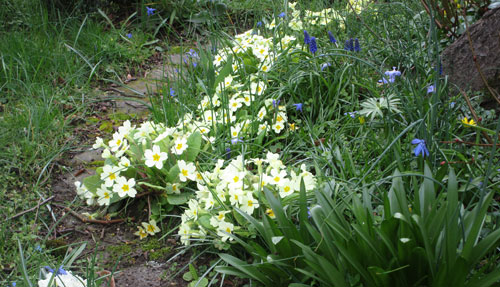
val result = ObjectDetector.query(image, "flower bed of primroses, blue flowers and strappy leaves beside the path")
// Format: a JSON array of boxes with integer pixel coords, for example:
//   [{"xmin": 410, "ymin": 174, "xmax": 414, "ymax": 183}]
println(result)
[{"xmin": 3, "ymin": 1, "xmax": 500, "ymax": 286}]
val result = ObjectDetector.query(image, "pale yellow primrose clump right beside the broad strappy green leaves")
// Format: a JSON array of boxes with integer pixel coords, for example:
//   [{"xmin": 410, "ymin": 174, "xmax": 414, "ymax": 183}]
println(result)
[{"xmin": 178, "ymin": 152, "xmax": 316, "ymax": 248}]
